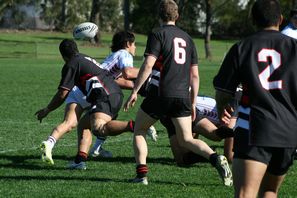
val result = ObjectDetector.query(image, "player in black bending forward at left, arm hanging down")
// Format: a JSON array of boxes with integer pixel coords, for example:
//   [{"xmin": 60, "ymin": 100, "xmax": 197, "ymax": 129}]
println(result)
[{"xmin": 36, "ymin": 39, "xmax": 123, "ymax": 168}]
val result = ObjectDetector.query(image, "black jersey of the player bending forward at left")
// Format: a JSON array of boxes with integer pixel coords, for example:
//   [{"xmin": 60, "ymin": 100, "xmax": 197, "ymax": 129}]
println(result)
[{"xmin": 59, "ymin": 53, "xmax": 121, "ymax": 94}]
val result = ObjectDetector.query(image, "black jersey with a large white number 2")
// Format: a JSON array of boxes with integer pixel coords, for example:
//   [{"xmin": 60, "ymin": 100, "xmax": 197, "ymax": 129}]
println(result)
[{"xmin": 214, "ymin": 30, "xmax": 297, "ymax": 147}]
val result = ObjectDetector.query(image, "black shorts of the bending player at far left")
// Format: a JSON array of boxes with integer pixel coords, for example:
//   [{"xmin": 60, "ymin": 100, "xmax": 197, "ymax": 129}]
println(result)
[{"xmin": 90, "ymin": 93, "xmax": 124, "ymax": 119}]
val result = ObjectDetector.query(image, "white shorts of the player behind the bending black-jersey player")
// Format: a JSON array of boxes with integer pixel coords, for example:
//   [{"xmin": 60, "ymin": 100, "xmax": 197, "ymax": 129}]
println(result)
[{"xmin": 65, "ymin": 86, "xmax": 91, "ymax": 109}]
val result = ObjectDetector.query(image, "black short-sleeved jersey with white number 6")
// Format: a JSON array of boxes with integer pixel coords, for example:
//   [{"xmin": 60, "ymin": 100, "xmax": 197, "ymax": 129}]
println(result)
[{"xmin": 144, "ymin": 25, "xmax": 198, "ymax": 98}]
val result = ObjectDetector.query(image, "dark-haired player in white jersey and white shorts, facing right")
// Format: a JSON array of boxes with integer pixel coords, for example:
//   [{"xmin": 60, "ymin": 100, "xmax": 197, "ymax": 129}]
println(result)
[{"xmin": 35, "ymin": 31, "xmax": 156, "ymax": 164}]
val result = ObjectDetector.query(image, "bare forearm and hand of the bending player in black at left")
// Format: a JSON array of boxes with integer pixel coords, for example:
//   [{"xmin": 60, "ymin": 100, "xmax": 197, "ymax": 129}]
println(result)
[{"xmin": 35, "ymin": 88, "xmax": 69, "ymax": 122}]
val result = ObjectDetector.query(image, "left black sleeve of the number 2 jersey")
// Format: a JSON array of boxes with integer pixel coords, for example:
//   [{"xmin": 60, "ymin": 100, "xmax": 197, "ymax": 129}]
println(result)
[{"xmin": 213, "ymin": 44, "xmax": 239, "ymax": 94}]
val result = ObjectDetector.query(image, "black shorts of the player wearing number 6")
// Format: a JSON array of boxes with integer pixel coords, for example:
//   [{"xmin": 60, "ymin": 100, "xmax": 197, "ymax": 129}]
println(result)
[{"xmin": 141, "ymin": 96, "xmax": 192, "ymax": 120}]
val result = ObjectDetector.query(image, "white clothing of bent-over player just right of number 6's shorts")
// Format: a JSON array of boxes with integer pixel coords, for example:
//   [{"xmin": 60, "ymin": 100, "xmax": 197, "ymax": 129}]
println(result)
[{"xmin": 196, "ymin": 96, "xmax": 220, "ymax": 125}]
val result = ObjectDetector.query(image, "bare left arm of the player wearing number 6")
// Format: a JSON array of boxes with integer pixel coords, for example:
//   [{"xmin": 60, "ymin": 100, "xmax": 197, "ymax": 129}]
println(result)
[{"xmin": 124, "ymin": 56, "xmax": 157, "ymax": 111}]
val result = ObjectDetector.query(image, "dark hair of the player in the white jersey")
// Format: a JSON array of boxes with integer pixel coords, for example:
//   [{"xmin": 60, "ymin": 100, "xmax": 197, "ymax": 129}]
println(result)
[{"xmin": 110, "ymin": 31, "xmax": 135, "ymax": 52}]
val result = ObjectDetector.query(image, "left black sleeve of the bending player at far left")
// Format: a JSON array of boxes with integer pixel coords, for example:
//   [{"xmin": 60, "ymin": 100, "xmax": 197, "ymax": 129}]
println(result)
[{"xmin": 58, "ymin": 65, "xmax": 75, "ymax": 90}]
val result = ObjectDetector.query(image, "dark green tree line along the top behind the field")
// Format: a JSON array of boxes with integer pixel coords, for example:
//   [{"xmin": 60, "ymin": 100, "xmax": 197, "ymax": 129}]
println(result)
[{"xmin": 0, "ymin": 0, "xmax": 297, "ymax": 59}]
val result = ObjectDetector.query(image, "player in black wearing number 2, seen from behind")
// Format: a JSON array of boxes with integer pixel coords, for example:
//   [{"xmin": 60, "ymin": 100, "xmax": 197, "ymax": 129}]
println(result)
[{"xmin": 214, "ymin": 0, "xmax": 297, "ymax": 197}]
